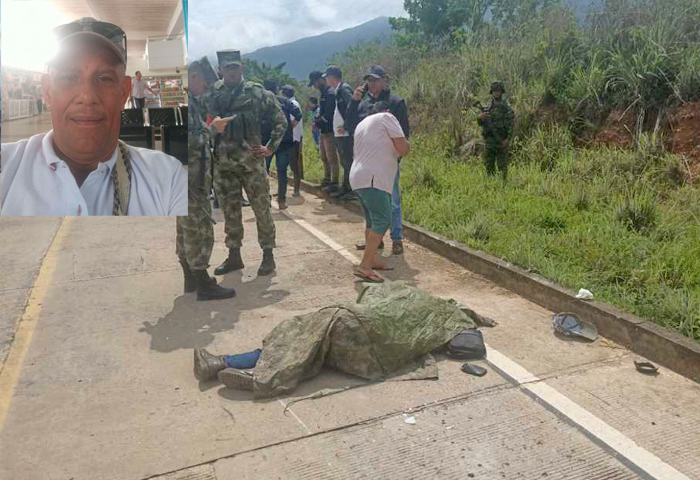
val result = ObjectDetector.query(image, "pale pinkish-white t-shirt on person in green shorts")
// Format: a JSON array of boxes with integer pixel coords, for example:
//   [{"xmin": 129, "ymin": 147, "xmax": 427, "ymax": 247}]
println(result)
[{"xmin": 350, "ymin": 112, "xmax": 404, "ymax": 194}]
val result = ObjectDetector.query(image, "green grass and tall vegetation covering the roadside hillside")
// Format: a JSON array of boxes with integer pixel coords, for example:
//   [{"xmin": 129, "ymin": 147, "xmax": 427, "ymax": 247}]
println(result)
[{"xmin": 296, "ymin": 0, "xmax": 700, "ymax": 340}]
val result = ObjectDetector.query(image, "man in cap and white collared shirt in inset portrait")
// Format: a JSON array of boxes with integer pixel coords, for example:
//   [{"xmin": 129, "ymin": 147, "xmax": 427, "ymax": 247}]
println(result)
[{"xmin": 0, "ymin": 18, "xmax": 187, "ymax": 216}]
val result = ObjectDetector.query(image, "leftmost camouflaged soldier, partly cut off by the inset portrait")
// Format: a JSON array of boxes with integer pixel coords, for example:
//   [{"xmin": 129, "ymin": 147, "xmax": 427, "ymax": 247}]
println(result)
[{"xmin": 176, "ymin": 57, "xmax": 236, "ymax": 300}]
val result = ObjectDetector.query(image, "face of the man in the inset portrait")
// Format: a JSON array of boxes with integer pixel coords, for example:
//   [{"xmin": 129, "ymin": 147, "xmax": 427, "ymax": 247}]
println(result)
[{"xmin": 41, "ymin": 43, "xmax": 131, "ymax": 163}]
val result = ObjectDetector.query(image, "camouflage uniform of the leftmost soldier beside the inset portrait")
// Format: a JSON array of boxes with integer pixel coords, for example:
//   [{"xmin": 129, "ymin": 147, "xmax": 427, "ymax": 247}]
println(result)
[{"xmin": 176, "ymin": 91, "xmax": 214, "ymax": 270}]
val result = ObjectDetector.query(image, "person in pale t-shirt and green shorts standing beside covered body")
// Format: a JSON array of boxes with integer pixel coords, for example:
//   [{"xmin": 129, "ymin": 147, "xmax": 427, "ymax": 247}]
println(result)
[{"xmin": 350, "ymin": 101, "xmax": 410, "ymax": 282}]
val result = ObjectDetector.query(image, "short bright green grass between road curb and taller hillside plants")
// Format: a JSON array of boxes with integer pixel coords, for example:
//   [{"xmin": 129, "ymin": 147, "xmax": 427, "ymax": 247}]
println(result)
[{"xmin": 304, "ymin": 125, "xmax": 700, "ymax": 340}]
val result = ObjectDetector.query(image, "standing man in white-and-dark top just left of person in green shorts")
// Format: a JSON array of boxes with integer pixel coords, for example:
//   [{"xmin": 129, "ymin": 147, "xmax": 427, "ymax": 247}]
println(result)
[{"xmin": 325, "ymin": 66, "xmax": 355, "ymax": 200}]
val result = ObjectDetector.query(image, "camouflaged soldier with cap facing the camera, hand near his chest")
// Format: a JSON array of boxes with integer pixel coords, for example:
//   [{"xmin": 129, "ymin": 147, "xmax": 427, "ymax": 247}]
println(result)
[{"xmin": 210, "ymin": 50, "xmax": 287, "ymax": 275}]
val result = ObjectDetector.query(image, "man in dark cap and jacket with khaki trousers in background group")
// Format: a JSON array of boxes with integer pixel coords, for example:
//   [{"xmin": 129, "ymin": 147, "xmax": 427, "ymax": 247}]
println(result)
[{"xmin": 309, "ymin": 71, "xmax": 339, "ymax": 193}]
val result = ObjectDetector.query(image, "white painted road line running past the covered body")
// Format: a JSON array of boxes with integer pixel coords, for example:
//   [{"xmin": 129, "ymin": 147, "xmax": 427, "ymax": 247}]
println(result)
[{"xmin": 274, "ymin": 197, "xmax": 690, "ymax": 480}]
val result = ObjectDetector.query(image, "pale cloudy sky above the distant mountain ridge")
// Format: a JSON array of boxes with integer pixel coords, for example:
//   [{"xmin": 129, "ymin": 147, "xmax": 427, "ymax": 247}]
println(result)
[{"xmin": 188, "ymin": 0, "xmax": 405, "ymax": 58}]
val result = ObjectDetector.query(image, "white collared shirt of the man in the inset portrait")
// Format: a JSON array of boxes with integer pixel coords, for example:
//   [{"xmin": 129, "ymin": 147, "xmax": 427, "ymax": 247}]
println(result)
[{"xmin": 0, "ymin": 130, "xmax": 187, "ymax": 216}]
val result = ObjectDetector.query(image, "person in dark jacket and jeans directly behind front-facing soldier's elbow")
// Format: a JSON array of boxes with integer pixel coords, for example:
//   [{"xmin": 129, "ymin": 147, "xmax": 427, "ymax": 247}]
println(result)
[{"xmin": 262, "ymin": 79, "xmax": 302, "ymax": 210}]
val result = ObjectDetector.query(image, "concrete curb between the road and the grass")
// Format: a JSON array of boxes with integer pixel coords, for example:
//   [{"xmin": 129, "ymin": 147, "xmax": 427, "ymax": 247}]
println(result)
[{"xmin": 273, "ymin": 173, "xmax": 700, "ymax": 383}]
